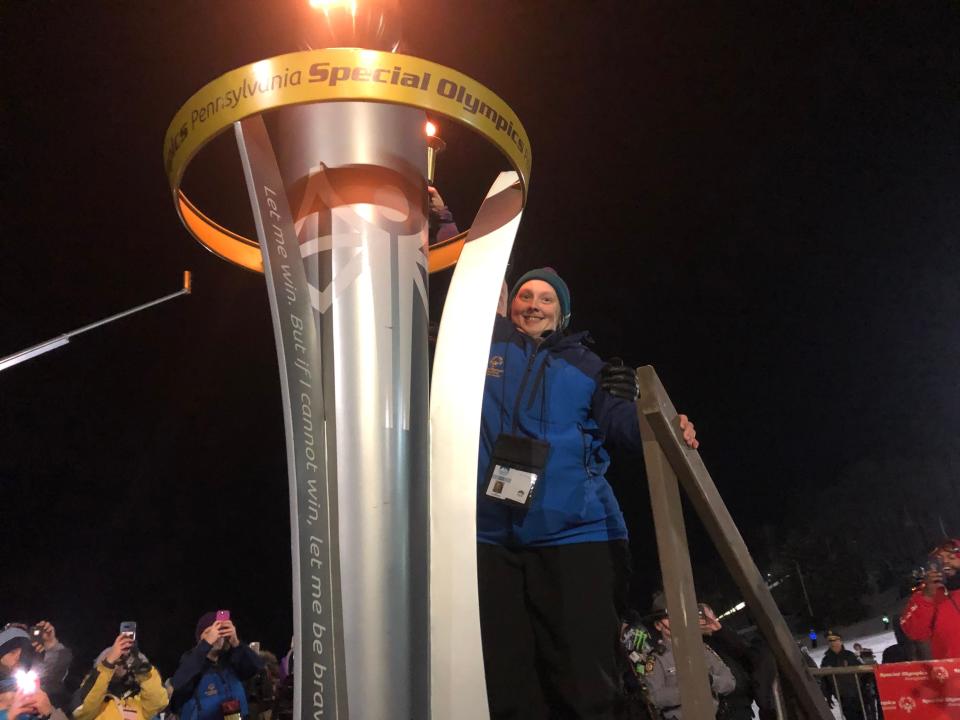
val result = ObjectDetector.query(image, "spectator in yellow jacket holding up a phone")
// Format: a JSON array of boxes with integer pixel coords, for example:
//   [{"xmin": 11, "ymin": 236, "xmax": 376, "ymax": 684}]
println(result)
[{"xmin": 72, "ymin": 633, "xmax": 169, "ymax": 720}]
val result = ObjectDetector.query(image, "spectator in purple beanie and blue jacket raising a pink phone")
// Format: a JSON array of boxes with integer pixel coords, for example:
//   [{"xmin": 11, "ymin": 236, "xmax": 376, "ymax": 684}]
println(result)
[{"xmin": 170, "ymin": 610, "xmax": 263, "ymax": 720}]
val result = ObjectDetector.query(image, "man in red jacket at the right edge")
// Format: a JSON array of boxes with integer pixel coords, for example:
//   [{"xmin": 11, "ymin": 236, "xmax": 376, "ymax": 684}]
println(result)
[{"xmin": 900, "ymin": 538, "xmax": 960, "ymax": 660}]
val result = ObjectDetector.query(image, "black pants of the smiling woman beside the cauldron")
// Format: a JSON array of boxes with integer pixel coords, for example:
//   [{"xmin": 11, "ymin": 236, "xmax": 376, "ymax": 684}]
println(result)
[{"xmin": 477, "ymin": 540, "xmax": 630, "ymax": 720}]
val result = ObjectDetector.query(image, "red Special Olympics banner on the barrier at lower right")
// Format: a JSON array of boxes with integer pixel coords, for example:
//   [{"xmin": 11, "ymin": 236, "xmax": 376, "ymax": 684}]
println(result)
[{"xmin": 874, "ymin": 658, "xmax": 960, "ymax": 720}]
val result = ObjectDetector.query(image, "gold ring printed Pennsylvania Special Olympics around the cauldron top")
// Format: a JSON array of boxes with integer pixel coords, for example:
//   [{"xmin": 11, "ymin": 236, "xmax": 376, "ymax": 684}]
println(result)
[{"xmin": 163, "ymin": 48, "xmax": 532, "ymax": 272}]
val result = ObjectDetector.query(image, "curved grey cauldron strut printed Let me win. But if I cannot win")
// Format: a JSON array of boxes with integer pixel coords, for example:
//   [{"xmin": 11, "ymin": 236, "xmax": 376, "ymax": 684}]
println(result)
[{"xmin": 236, "ymin": 116, "xmax": 347, "ymax": 720}]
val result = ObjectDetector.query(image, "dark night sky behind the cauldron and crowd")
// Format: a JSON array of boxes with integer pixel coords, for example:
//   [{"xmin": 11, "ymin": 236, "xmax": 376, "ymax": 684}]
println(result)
[{"xmin": 0, "ymin": 0, "xmax": 960, "ymax": 674}]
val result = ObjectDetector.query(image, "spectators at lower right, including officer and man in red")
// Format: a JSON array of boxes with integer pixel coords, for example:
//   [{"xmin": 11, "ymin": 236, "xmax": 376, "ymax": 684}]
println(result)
[{"xmin": 623, "ymin": 539, "xmax": 960, "ymax": 720}]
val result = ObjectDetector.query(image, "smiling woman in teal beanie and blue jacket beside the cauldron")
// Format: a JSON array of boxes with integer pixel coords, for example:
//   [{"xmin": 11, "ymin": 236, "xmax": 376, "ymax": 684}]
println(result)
[{"xmin": 477, "ymin": 268, "xmax": 698, "ymax": 720}]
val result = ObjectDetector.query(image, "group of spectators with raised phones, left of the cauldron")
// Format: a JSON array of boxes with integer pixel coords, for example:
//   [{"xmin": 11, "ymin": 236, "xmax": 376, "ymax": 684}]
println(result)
[{"xmin": 0, "ymin": 610, "xmax": 284, "ymax": 720}]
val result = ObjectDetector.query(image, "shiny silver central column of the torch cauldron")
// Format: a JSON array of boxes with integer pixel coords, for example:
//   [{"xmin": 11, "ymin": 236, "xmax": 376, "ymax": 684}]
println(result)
[{"xmin": 268, "ymin": 102, "xmax": 429, "ymax": 720}]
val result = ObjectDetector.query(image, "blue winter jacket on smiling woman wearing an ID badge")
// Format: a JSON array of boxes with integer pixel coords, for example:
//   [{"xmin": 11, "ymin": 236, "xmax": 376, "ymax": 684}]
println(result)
[{"xmin": 477, "ymin": 316, "xmax": 642, "ymax": 546}]
